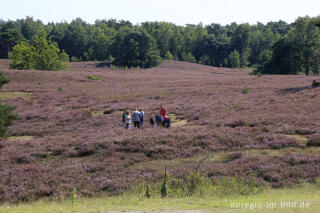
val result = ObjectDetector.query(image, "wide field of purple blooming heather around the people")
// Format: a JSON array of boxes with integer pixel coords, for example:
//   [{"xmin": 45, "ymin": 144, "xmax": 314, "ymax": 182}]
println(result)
[{"xmin": 0, "ymin": 60, "xmax": 320, "ymax": 202}]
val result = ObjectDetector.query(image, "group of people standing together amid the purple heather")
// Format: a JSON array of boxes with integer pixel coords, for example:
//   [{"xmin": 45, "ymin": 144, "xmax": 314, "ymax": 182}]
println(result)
[{"xmin": 122, "ymin": 105, "xmax": 171, "ymax": 129}]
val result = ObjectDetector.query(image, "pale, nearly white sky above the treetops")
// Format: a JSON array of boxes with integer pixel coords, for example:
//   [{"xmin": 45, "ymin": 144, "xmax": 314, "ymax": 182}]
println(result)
[{"xmin": 0, "ymin": 0, "xmax": 320, "ymax": 25}]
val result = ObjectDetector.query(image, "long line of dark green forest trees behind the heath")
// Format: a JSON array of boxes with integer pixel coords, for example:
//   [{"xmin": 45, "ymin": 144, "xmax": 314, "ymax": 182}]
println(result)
[{"xmin": 0, "ymin": 17, "xmax": 320, "ymax": 74}]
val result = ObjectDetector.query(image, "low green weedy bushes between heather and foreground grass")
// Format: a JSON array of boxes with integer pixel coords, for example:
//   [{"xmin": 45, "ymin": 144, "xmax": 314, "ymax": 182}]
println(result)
[{"xmin": 134, "ymin": 172, "xmax": 262, "ymax": 198}]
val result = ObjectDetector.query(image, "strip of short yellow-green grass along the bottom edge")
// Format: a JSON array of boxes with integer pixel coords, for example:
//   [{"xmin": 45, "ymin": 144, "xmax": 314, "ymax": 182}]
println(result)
[{"xmin": 0, "ymin": 186, "xmax": 320, "ymax": 213}]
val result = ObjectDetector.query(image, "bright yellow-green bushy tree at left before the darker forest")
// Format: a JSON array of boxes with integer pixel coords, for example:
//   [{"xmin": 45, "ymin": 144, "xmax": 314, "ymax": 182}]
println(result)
[{"xmin": 9, "ymin": 31, "xmax": 69, "ymax": 70}]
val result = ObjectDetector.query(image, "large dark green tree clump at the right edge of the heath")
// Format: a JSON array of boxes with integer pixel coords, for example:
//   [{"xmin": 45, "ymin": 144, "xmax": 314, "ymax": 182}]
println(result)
[{"xmin": 258, "ymin": 17, "xmax": 320, "ymax": 75}]
